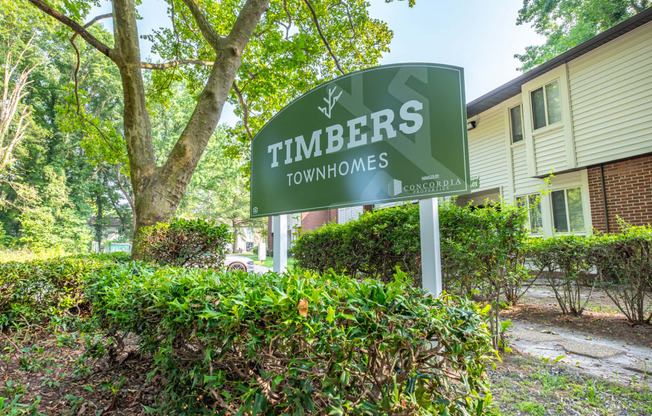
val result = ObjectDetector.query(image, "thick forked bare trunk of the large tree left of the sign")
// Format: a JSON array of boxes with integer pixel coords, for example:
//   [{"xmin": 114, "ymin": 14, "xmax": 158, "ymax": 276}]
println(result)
[{"xmin": 29, "ymin": 0, "xmax": 270, "ymax": 259}]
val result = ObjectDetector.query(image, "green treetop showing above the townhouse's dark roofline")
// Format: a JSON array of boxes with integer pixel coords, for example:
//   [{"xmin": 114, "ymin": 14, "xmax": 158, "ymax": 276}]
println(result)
[{"xmin": 515, "ymin": 0, "xmax": 652, "ymax": 71}]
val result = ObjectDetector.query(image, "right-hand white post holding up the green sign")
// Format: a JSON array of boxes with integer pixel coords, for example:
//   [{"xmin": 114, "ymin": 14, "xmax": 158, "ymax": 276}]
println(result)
[{"xmin": 419, "ymin": 198, "xmax": 442, "ymax": 296}]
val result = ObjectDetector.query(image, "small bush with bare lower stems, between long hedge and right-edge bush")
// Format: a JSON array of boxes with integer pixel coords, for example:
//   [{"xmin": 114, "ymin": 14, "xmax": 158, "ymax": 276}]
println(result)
[{"xmin": 529, "ymin": 235, "xmax": 596, "ymax": 316}]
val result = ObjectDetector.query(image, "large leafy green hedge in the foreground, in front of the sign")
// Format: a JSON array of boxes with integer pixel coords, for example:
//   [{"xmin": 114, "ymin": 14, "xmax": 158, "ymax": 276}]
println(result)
[{"xmin": 89, "ymin": 263, "xmax": 500, "ymax": 415}]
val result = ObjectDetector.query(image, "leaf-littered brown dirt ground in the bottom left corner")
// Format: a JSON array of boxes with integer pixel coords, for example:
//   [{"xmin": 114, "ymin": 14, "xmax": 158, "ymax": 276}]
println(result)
[{"xmin": 0, "ymin": 328, "xmax": 160, "ymax": 416}]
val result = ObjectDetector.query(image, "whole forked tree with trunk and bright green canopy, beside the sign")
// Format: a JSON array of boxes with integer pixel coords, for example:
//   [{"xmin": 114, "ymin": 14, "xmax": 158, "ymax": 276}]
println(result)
[{"xmin": 29, "ymin": 0, "xmax": 402, "ymax": 258}]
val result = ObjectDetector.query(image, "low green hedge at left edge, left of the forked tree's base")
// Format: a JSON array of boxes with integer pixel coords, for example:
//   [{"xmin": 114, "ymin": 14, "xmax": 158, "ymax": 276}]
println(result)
[{"xmin": 0, "ymin": 253, "xmax": 126, "ymax": 330}]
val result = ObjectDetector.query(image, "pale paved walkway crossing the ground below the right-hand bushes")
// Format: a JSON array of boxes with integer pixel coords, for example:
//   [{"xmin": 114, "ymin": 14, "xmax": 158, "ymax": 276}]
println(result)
[{"xmin": 508, "ymin": 320, "xmax": 652, "ymax": 386}]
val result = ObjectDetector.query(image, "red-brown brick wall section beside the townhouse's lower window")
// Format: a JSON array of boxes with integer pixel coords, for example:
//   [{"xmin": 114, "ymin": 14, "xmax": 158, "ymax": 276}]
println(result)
[{"xmin": 587, "ymin": 155, "xmax": 652, "ymax": 232}]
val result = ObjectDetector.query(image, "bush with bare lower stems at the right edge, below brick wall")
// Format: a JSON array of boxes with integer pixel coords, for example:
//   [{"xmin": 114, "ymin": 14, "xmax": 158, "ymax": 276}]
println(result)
[{"xmin": 590, "ymin": 224, "xmax": 652, "ymax": 324}]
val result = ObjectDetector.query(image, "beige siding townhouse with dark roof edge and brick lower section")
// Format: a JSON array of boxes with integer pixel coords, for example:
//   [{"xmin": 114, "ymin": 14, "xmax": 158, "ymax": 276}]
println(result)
[{"xmin": 458, "ymin": 9, "xmax": 652, "ymax": 234}]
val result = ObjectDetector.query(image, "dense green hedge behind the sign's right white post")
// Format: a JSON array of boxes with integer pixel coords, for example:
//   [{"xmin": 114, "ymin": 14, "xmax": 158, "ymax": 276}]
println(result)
[{"xmin": 292, "ymin": 203, "xmax": 529, "ymax": 301}]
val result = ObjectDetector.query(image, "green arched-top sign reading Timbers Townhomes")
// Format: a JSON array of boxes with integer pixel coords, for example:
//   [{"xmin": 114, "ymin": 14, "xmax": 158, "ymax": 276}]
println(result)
[{"xmin": 251, "ymin": 64, "xmax": 470, "ymax": 217}]
